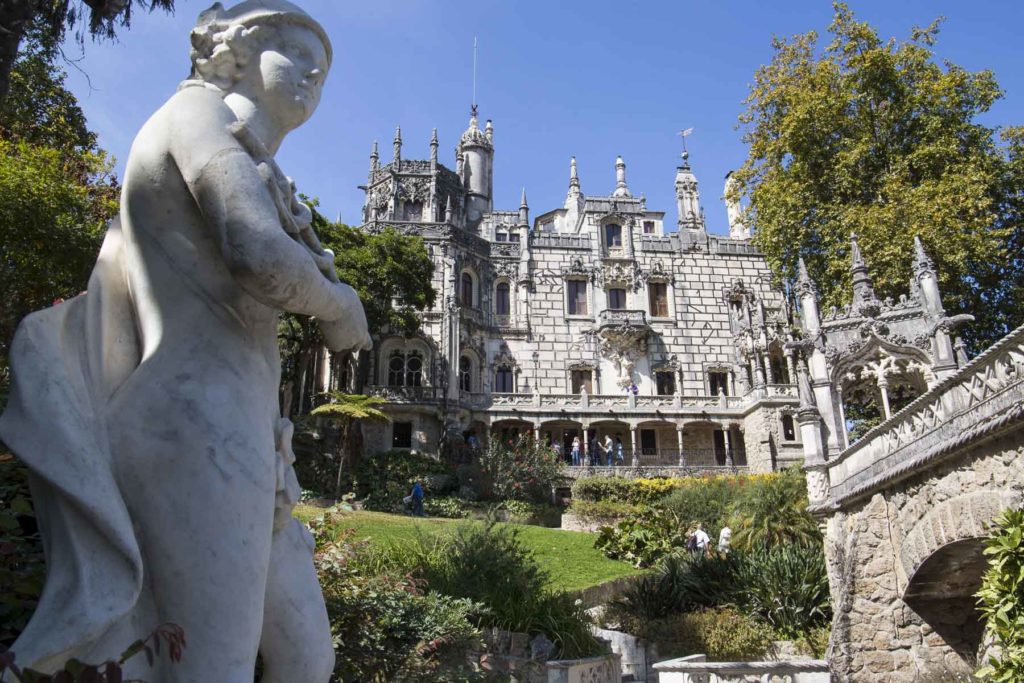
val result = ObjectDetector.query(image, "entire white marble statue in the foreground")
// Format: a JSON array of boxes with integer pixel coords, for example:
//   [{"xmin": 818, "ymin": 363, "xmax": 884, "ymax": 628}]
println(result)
[{"xmin": 0, "ymin": 0, "xmax": 371, "ymax": 683}]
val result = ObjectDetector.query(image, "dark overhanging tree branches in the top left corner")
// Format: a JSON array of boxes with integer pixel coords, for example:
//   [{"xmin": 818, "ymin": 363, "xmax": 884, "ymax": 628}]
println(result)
[{"xmin": 0, "ymin": 0, "xmax": 174, "ymax": 103}]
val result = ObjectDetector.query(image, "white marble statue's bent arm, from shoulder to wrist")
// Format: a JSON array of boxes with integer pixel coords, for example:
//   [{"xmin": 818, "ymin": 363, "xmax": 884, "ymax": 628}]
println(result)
[{"xmin": 169, "ymin": 89, "xmax": 366, "ymax": 326}]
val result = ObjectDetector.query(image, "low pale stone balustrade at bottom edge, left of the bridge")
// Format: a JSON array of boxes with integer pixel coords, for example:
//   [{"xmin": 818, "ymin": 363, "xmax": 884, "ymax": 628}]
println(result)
[{"xmin": 654, "ymin": 654, "xmax": 831, "ymax": 683}]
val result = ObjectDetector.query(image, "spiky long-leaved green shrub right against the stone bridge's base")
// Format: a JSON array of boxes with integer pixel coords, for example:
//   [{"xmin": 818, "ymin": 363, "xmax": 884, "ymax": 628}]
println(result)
[{"xmin": 735, "ymin": 545, "xmax": 831, "ymax": 639}]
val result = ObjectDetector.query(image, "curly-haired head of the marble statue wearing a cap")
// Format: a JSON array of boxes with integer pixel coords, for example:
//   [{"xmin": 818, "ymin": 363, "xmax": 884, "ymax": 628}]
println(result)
[{"xmin": 190, "ymin": 0, "xmax": 332, "ymax": 125}]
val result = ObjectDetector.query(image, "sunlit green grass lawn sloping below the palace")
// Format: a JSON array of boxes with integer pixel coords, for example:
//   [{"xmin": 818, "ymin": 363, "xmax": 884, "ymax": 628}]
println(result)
[{"xmin": 295, "ymin": 505, "xmax": 640, "ymax": 591}]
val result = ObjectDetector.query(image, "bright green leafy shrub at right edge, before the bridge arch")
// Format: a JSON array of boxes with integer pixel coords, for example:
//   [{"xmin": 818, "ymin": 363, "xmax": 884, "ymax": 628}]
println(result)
[{"xmin": 977, "ymin": 509, "xmax": 1024, "ymax": 683}]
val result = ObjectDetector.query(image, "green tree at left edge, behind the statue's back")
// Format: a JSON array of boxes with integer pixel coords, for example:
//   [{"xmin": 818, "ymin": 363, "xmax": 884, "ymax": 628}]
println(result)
[{"xmin": 0, "ymin": 45, "xmax": 118, "ymax": 393}]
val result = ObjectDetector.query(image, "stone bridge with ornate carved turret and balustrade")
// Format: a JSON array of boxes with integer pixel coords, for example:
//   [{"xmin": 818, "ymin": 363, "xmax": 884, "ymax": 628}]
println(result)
[{"xmin": 798, "ymin": 243, "xmax": 1024, "ymax": 682}]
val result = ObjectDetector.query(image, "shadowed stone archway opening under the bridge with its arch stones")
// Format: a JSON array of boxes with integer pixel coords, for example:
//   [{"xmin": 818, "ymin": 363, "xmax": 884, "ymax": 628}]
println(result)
[{"xmin": 899, "ymin": 490, "xmax": 1021, "ymax": 661}]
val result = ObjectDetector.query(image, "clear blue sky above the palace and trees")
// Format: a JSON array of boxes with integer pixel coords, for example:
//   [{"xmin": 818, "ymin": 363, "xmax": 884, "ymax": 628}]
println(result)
[{"xmin": 67, "ymin": 0, "xmax": 1024, "ymax": 232}]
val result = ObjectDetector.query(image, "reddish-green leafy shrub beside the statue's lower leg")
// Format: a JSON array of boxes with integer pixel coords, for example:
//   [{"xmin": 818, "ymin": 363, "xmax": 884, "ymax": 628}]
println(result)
[{"xmin": 310, "ymin": 512, "xmax": 484, "ymax": 681}]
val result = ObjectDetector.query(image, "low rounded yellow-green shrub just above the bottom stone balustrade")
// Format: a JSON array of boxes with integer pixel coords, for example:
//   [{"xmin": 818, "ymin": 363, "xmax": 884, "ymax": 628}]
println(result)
[{"xmin": 637, "ymin": 607, "xmax": 772, "ymax": 661}]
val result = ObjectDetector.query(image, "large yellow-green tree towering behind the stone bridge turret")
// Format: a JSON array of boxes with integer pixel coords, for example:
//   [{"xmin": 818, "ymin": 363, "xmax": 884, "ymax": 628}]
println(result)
[{"xmin": 735, "ymin": 3, "xmax": 1024, "ymax": 347}]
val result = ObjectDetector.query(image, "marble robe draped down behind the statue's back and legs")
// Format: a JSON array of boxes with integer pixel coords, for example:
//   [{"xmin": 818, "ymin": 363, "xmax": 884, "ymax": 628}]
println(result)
[{"xmin": 0, "ymin": 220, "xmax": 149, "ymax": 669}]
